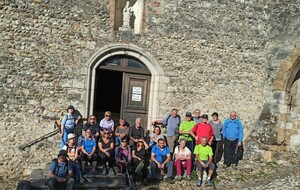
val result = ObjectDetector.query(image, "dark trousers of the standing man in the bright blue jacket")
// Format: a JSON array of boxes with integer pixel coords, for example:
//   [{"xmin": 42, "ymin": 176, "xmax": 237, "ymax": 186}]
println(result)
[{"xmin": 224, "ymin": 138, "xmax": 238, "ymax": 165}]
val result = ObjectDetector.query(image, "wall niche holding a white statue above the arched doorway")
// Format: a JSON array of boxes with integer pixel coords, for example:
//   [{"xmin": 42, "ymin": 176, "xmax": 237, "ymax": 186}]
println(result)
[{"xmin": 109, "ymin": 0, "xmax": 145, "ymax": 34}]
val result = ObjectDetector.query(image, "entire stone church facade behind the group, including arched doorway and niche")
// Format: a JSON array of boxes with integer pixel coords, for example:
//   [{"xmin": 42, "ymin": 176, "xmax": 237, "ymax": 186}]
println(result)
[{"xmin": 0, "ymin": 0, "xmax": 300, "ymax": 178}]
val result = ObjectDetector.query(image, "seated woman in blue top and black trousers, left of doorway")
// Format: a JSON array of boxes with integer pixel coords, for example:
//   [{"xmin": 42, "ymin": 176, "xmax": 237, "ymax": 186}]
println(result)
[{"xmin": 81, "ymin": 129, "xmax": 97, "ymax": 174}]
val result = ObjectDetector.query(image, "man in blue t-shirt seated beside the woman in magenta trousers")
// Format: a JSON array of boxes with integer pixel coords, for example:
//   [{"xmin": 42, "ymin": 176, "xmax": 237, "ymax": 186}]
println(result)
[{"xmin": 150, "ymin": 138, "xmax": 173, "ymax": 183}]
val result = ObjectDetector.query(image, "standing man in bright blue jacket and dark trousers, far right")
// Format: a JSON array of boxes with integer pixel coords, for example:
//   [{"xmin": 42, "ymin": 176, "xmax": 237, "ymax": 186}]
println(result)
[{"xmin": 222, "ymin": 111, "xmax": 243, "ymax": 167}]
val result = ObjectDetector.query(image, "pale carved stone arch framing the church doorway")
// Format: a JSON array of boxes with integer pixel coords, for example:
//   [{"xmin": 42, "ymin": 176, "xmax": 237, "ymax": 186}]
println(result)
[{"xmin": 85, "ymin": 44, "xmax": 169, "ymax": 128}]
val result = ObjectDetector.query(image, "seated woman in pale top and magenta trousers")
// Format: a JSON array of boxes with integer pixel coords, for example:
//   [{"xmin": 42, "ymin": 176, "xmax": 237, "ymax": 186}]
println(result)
[{"xmin": 174, "ymin": 138, "xmax": 192, "ymax": 181}]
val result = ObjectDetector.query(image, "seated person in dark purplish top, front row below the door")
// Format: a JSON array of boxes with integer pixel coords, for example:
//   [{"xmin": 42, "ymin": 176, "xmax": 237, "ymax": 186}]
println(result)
[{"xmin": 115, "ymin": 138, "xmax": 132, "ymax": 173}]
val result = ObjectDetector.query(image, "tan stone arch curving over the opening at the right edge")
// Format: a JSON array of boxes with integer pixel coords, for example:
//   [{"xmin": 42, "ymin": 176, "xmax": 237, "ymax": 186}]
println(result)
[{"xmin": 272, "ymin": 45, "xmax": 300, "ymax": 92}]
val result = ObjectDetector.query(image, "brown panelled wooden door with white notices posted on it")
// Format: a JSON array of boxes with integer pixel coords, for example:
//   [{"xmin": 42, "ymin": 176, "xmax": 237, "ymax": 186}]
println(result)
[{"xmin": 121, "ymin": 73, "xmax": 150, "ymax": 131}]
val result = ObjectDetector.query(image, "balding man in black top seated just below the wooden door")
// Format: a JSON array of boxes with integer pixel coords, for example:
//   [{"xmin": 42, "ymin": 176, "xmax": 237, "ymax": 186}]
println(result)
[{"xmin": 129, "ymin": 117, "xmax": 144, "ymax": 147}]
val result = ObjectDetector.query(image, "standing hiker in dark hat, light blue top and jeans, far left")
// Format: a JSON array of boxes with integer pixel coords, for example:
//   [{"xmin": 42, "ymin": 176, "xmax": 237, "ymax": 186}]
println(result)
[{"xmin": 60, "ymin": 105, "xmax": 81, "ymax": 149}]
